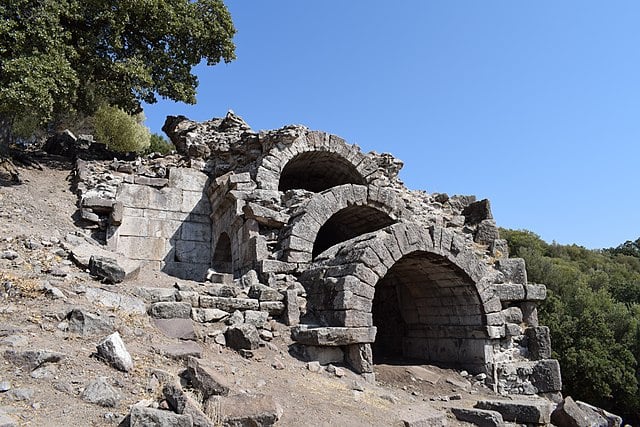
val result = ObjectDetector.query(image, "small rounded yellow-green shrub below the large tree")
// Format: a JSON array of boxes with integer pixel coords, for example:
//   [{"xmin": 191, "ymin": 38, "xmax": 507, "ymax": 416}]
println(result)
[{"xmin": 94, "ymin": 105, "xmax": 151, "ymax": 153}]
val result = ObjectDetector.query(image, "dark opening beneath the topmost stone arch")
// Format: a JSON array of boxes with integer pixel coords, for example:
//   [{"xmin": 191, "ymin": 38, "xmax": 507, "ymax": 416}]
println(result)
[{"xmin": 278, "ymin": 151, "xmax": 365, "ymax": 193}]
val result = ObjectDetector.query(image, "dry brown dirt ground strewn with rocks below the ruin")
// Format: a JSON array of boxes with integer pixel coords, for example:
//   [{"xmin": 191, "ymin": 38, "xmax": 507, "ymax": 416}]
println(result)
[{"xmin": 0, "ymin": 158, "xmax": 500, "ymax": 427}]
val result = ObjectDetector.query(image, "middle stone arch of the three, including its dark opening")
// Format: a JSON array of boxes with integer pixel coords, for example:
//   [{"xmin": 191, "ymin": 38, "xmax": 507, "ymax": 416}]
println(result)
[{"xmin": 280, "ymin": 184, "xmax": 403, "ymax": 263}]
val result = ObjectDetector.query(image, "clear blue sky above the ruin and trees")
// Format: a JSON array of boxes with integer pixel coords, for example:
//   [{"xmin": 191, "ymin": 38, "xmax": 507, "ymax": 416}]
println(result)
[{"xmin": 145, "ymin": 0, "xmax": 640, "ymax": 248}]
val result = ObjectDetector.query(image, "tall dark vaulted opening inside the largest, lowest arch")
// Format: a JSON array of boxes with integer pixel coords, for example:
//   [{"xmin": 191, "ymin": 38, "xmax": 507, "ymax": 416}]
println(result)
[{"xmin": 372, "ymin": 252, "xmax": 484, "ymax": 369}]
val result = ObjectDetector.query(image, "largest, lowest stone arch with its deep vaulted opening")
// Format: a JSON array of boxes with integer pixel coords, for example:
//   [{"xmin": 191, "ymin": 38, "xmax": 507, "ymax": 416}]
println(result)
[{"xmin": 301, "ymin": 223, "xmax": 504, "ymax": 372}]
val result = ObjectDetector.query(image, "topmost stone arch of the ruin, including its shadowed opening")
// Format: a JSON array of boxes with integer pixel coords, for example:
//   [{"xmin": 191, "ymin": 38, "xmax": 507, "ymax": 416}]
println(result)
[{"xmin": 256, "ymin": 131, "xmax": 378, "ymax": 192}]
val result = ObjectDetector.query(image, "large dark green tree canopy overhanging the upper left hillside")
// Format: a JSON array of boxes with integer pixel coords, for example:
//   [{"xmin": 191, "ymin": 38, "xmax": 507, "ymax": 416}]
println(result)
[{"xmin": 0, "ymin": 0, "xmax": 235, "ymax": 139}]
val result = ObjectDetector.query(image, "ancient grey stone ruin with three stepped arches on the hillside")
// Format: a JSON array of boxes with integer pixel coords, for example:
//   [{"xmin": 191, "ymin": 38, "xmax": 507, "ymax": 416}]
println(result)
[{"xmin": 78, "ymin": 113, "xmax": 561, "ymax": 394}]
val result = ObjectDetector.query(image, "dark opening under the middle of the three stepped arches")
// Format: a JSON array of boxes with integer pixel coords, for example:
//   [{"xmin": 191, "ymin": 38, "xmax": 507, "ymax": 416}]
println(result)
[{"xmin": 312, "ymin": 206, "xmax": 395, "ymax": 258}]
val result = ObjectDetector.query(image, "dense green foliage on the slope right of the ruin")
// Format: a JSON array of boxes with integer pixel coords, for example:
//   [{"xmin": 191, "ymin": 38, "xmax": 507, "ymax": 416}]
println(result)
[{"xmin": 501, "ymin": 229, "xmax": 640, "ymax": 422}]
